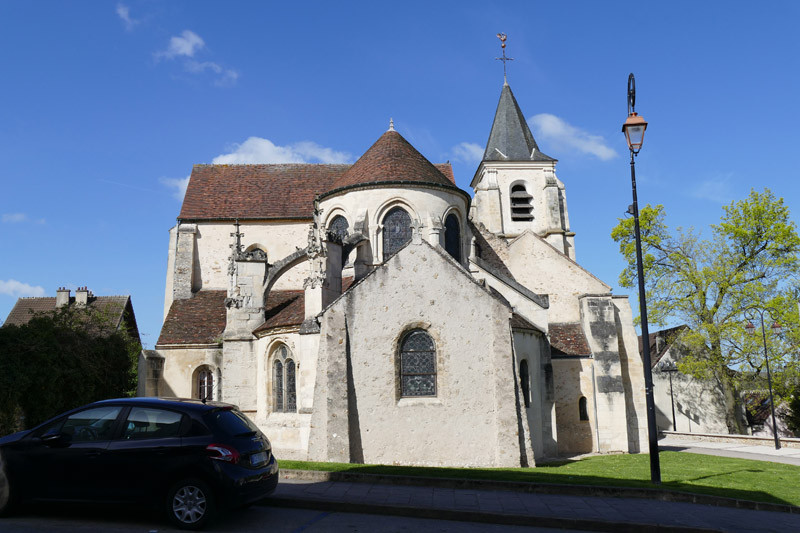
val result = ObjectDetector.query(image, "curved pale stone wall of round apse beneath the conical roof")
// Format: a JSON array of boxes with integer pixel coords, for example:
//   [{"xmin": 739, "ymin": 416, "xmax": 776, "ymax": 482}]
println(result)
[{"xmin": 320, "ymin": 186, "xmax": 469, "ymax": 264}]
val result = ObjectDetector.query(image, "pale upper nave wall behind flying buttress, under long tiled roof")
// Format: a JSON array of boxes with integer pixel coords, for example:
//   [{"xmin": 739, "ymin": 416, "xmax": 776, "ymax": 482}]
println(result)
[{"xmin": 194, "ymin": 221, "xmax": 309, "ymax": 290}]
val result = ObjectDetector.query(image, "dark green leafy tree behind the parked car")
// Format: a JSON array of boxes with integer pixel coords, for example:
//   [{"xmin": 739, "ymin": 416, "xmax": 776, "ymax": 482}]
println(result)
[{"xmin": 0, "ymin": 308, "xmax": 141, "ymax": 435}]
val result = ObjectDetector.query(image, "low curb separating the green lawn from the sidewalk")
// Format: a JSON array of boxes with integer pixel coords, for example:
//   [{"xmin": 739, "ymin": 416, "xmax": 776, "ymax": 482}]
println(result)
[{"xmin": 281, "ymin": 470, "xmax": 800, "ymax": 514}]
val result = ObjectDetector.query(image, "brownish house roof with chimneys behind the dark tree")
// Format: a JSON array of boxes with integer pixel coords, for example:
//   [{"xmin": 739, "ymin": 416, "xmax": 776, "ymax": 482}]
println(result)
[{"xmin": 3, "ymin": 295, "xmax": 139, "ymax": 340}]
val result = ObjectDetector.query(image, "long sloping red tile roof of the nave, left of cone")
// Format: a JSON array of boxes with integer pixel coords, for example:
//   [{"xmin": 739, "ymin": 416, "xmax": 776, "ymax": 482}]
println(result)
[{"xmin": 178, "ymin": 164, "xmax": 350, "ymax": 220}]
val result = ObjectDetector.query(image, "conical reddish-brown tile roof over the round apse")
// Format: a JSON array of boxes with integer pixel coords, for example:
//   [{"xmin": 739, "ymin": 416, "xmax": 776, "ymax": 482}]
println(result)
[{"xmin": 322, "ymin": 130, "xmax": 463, "ymax": 194}]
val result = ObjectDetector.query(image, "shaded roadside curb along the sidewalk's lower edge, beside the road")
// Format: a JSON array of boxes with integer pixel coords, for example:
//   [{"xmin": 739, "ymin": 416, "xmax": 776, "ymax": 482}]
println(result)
[{"xmin": 261, "ymin": 496, "xmax": 721, "ymax": 533}]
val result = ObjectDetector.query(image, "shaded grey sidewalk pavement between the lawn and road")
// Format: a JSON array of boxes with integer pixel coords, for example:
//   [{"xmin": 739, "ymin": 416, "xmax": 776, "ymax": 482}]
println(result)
[{"xmin": 264, "ymin": 472, "xmax": 800, "ymax": 533}]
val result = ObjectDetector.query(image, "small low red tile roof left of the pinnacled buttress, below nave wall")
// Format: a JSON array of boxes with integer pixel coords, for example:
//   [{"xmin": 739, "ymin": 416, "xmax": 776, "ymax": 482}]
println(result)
[{"xmin": 156, "ymin": 291, "xmax": 228, "ymax": 346}]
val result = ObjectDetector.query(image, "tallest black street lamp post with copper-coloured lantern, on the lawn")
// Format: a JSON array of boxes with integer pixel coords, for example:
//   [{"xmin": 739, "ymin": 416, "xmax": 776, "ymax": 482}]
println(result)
[{"xmin": 622, "ymin": 73, "xmax": 661, "ymax": 485}]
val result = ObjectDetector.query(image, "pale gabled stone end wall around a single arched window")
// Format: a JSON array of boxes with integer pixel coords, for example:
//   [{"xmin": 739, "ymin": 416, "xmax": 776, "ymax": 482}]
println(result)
[{"xmin": 318, "ymin": 244, "xmax": 520, "ymax": 466}]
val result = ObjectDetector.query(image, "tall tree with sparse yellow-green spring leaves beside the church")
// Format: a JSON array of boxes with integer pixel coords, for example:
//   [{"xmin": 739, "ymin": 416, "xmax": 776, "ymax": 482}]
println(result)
[{"xmin": 611, "ymin": 189, "xmax": 800, "ymax": 432}]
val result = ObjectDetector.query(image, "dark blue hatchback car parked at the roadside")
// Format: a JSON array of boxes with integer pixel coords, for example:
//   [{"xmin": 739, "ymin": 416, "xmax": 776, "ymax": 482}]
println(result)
[{"xmin": 0, "ymin": 398, "xmax": 278, "ymax": 529}]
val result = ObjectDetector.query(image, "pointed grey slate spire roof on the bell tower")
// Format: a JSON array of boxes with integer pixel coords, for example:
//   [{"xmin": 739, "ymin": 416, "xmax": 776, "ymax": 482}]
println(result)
[{"xmin": 483, "ymin": 83, "xmax": 555, "ymax": 161}]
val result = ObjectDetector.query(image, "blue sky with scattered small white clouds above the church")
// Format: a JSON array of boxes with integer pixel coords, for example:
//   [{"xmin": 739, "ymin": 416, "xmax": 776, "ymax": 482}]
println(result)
[{"xmin": 0, "ymin": 0, "xmax": 800, "ymax": 347}]
